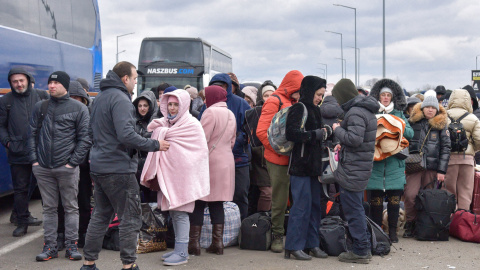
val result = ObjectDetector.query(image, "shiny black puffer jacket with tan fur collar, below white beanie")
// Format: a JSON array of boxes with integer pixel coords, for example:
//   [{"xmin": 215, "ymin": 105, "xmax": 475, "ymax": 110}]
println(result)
[{"xmin": 408, "ymin": 103, "xmax": 451, "ymax": 174}]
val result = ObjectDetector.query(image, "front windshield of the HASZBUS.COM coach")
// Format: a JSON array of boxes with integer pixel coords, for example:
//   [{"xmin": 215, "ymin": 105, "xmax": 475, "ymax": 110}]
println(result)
[{"xmin": 139, "ymin": 40, "xmax": 203, "ymax": 65}]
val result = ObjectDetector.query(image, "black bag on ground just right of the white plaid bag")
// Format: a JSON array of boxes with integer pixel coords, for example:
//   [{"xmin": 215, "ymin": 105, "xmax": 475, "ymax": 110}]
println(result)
[{"xmin": 238, "ymin": 212, "xmax": 272, "ymax": 250}]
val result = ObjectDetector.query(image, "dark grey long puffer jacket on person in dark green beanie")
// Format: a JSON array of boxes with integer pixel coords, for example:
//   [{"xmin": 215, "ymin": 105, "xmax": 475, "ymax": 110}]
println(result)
[{"xmin": 334, "ymin": 95, "xmax": 380, "ymax": 192}]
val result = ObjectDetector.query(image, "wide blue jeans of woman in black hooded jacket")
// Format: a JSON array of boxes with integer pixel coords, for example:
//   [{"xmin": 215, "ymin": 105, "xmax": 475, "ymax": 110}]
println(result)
[{"xmin": 285, "ymin": 175, "xmax": 322, "ymax": 250}]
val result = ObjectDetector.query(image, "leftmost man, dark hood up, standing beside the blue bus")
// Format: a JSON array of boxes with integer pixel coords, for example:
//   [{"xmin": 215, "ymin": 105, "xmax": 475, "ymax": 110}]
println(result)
[{"xmin": 0, "ymin": 68, "xmax": 48, "ymax": 237}]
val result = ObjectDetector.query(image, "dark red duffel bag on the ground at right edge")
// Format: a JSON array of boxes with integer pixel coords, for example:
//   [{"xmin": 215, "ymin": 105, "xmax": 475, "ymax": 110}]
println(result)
[{"xmin": 450, "ymin": 209, "xmax": 480, "ymax": 243}]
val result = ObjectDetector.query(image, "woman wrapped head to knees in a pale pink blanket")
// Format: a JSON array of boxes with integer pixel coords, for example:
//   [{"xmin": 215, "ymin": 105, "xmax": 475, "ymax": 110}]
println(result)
[{"xmin": 141, "ymin": 90, "xmax": 210, "ymax": 265}]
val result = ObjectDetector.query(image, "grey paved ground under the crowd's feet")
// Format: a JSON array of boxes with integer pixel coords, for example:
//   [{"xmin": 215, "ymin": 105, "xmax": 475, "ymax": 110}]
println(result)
[{"xmin": 0, "ymin": 196, "xmax": 480, "ymax": 270}]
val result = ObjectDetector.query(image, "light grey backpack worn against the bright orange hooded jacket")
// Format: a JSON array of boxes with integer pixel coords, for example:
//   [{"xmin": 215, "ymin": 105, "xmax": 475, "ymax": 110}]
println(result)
[{"xmin": 267, "ymin": 95, "xmax": 308, "ymax": 156}]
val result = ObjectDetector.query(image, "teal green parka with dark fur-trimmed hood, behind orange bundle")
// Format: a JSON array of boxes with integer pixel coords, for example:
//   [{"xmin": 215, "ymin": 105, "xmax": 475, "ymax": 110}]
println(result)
[{"xmin": 367, "ymin": 79, "xmax": 413, "ymax": 190}]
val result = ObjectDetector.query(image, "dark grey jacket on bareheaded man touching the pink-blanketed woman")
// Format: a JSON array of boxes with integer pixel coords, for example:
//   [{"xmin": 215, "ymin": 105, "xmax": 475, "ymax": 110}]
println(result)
[{"xmin": 90, "ymin": 70, "xmax": 160, "ymax": 174}]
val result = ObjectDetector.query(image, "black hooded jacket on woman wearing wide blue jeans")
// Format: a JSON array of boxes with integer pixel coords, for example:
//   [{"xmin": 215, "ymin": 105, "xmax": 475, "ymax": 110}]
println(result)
[{"xmin": 285, "ymin": 76, "xmax": 327, "ymax": 176}]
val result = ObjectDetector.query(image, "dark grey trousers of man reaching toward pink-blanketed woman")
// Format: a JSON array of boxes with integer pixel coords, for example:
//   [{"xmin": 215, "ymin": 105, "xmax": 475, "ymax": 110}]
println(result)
[{"xmin": 83, "ymin": 173, "xmax": 142, "ymax": 264}]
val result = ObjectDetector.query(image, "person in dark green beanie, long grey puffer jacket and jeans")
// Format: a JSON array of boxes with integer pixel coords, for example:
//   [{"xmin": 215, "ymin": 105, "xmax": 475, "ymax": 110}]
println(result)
[{"xmin": 332, "ymin": 79, "xmax": 380, "ymax": 263}]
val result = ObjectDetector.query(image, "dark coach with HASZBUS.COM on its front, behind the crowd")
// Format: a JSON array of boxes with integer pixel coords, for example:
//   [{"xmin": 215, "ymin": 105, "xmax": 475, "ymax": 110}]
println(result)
[{"xmin": 137, "ymin": 37, "xmax": 232, "ymax": 94}]
